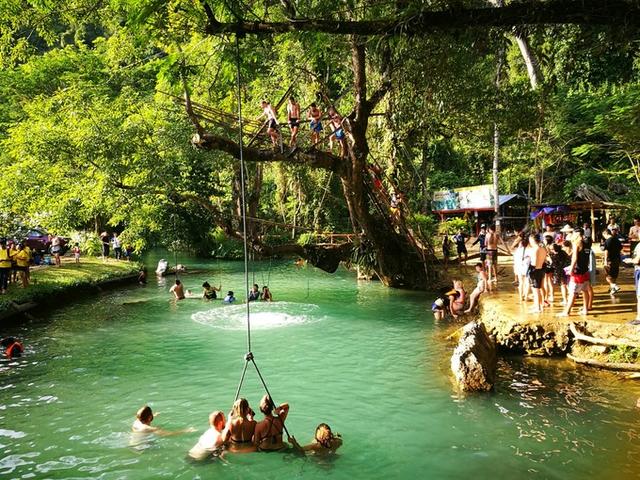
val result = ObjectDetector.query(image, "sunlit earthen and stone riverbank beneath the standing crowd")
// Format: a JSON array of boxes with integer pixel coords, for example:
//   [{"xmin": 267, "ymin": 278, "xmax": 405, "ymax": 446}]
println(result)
[{"xmin": 461, "ymin": 256, "xmax": 640, "ymax": 370}]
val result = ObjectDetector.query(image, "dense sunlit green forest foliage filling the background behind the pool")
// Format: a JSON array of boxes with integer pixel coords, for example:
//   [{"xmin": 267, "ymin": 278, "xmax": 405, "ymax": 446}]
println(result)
[{"xmin": 0, "ymin": 0, "xmax": 640, "ymax": 258}]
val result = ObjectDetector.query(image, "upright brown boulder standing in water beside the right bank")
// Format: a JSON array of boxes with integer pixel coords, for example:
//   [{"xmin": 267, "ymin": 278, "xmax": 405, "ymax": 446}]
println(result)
[{"xmin": 451, "ymin": 321, "xmax": 497, "ymax": 392}]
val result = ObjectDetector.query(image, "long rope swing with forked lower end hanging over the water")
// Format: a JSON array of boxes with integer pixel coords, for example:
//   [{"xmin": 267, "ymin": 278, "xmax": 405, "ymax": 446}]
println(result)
[{"xmin": 234, "ymin": 32, "xmax": 291, "ymax": 436}]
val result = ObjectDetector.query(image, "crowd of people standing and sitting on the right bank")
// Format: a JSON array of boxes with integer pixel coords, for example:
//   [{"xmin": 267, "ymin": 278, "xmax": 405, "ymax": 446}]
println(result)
[{"xmin": 432, "ymin": 218, "xmax": 640, "ymax": 323}]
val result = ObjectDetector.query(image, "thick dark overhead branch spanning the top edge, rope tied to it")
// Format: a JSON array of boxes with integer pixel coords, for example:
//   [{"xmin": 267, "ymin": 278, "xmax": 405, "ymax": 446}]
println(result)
[{"xmin": 206, "ymin": 0, "xmax": 640, "ymax": 36}]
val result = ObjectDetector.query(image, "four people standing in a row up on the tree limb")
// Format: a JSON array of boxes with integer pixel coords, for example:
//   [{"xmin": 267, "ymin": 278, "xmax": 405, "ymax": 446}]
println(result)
[{"xmin": 259, "ymin": 96, "xmax": 347, "ymax": 157}]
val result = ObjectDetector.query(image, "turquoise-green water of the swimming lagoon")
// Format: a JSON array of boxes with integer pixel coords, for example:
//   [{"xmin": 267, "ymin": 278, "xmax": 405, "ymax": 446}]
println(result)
[{"xmin": 0, "ymin": 260, "xmax": 640, "ymax": 480}]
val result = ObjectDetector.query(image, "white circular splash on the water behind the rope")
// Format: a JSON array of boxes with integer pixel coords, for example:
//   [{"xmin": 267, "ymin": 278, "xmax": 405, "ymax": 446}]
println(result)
[{"xmin": 191, "ymin": 302, "xmax": 321, "ymax": 330}]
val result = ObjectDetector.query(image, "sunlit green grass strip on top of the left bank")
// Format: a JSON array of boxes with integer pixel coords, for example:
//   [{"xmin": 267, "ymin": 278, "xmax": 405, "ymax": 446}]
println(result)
[{"xmin": 0, "ymin": 257, "xmax": 140, "ymax": 313}]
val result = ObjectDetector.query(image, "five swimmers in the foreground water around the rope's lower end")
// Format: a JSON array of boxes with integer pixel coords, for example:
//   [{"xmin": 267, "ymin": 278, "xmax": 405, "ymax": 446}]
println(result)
[{"xmin": 132, "ymin": 395, "xmax": 342, "ymax": 460}]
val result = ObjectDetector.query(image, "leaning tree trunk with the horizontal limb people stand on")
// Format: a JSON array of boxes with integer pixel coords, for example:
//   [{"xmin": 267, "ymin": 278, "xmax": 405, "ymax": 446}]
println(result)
[{"xmin": 181, "ymin": 37, "xmax": 434, "ymax": 289}]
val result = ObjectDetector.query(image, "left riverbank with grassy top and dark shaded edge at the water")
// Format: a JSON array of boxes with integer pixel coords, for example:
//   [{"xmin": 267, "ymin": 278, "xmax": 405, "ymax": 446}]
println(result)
[{"xmin": 0, "ymin": 257, "xmax": 140, "ymax": 320}]
